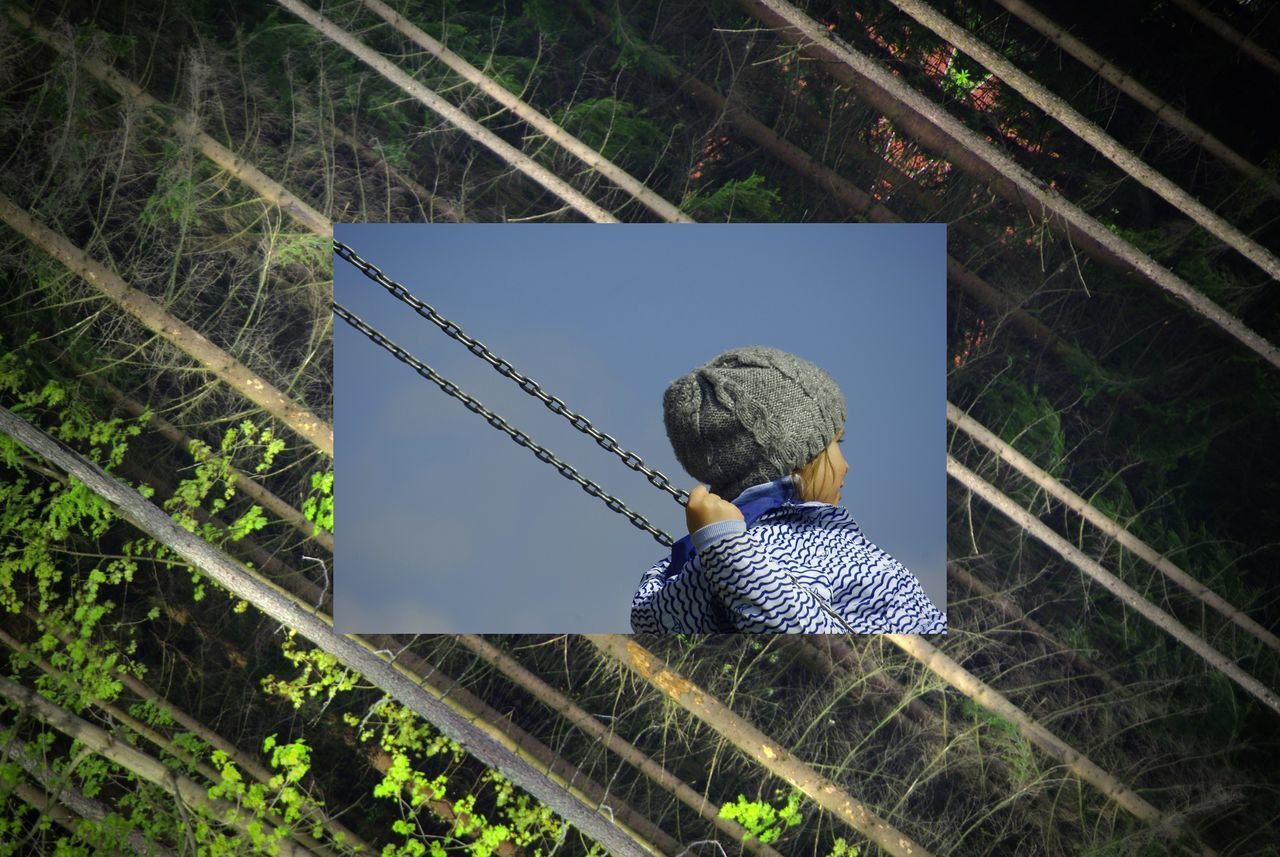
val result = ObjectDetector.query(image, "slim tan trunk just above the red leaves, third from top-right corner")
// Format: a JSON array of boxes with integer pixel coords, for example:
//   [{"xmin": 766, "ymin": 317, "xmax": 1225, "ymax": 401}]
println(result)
[{"xmin": 890, "ymin": 0, "xmax": 1280, "ymax": 281}]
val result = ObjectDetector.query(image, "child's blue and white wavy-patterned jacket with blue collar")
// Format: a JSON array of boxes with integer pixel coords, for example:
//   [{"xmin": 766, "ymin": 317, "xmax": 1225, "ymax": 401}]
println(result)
[{"xmin": 631, "ymin": 477, "xmax": 947, "ymax": 634}]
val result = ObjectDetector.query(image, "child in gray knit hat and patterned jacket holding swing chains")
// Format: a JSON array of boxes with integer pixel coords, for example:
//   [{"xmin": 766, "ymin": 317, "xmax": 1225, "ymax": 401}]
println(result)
[{"xmin": 631, "ymin": 347, "xmax": 947, "ymax": 633}]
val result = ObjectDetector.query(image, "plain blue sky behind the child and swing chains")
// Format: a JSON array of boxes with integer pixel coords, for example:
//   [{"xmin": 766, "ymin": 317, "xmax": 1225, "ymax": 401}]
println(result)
[{"xmin": 334, "ymin": 224, "xmax": 946, "ymax": 633}]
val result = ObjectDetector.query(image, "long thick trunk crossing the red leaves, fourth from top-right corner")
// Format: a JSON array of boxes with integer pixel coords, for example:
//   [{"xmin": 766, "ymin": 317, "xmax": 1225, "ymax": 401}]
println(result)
[{"xmin": 739, "ymin": 0, "xmax": 1280, "ymax": 368}]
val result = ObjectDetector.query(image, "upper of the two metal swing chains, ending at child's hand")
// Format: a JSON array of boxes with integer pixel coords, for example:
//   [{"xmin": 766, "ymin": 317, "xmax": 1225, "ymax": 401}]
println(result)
[{"xmin": 333, "ymin": 239, "xmax": 689, "ymax": 505}]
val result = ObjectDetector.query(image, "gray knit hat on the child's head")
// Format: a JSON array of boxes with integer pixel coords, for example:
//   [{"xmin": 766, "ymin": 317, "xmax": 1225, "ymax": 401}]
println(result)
[{"xmin": 662, "ymin": 345, "xmax": 847, "ymax": 500}]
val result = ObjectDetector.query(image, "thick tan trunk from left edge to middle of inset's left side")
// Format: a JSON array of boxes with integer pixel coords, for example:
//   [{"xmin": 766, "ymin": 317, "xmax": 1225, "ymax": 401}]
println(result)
[{"xmin": 0, "ymin": 193, "xmax": 333, "ymax": 458}]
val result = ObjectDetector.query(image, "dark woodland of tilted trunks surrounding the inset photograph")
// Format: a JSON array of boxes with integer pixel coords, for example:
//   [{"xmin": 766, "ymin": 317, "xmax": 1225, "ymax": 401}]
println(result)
[{"xmin": 0, "ymin": 0, "xmax": 1280, "ymax": 856}]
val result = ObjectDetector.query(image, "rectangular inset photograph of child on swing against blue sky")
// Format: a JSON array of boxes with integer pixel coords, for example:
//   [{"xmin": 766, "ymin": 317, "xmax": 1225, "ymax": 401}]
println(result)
[{"xmin": 334, "ymin": 224, "xmax": 947, "ymax": 633}]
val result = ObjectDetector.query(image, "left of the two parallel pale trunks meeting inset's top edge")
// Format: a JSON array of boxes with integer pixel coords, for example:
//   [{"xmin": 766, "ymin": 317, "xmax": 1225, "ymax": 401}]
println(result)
[{"xmin": 276, "ymin": 0, "xmax": 618, "ymax": 223}]
